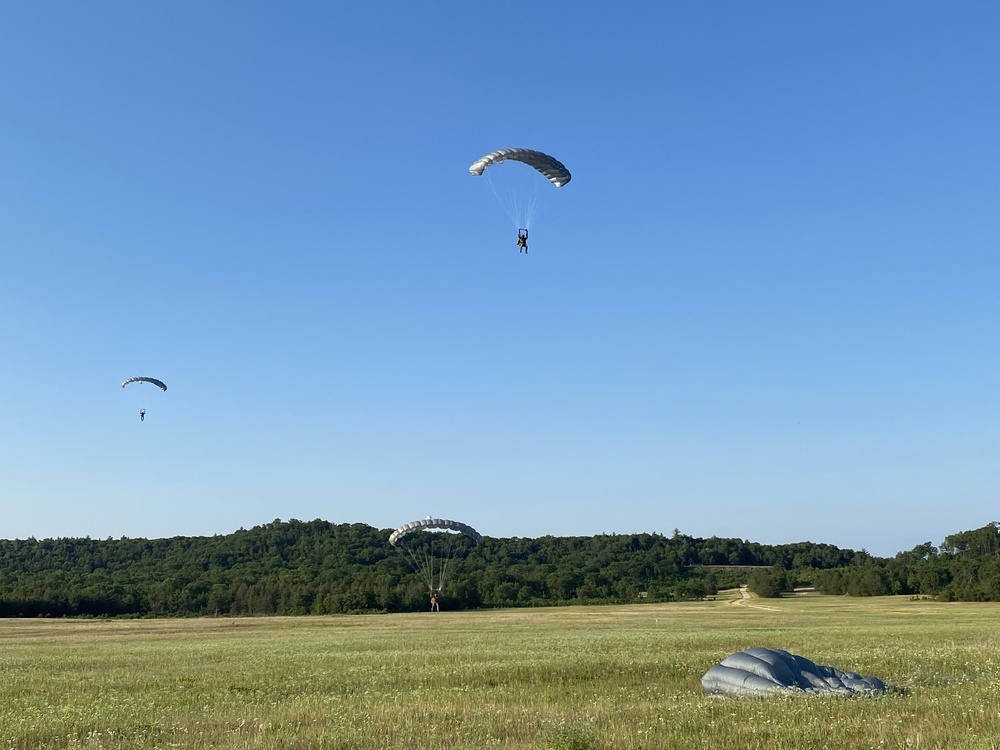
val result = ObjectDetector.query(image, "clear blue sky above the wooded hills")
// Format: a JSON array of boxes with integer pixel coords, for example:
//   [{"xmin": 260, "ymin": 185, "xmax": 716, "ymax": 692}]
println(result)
[{"xmin": 0, "ymin": 0, "xmax": 1000, "ymax": 555}]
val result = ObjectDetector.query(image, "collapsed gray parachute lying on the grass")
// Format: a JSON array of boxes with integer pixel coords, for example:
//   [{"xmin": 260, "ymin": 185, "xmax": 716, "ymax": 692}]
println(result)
[{"xmin": 701, "ymin": 648, "xmax": 886, "ymax": 696}]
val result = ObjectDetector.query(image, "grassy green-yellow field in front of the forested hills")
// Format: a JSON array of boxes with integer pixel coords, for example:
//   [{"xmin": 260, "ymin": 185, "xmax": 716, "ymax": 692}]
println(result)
[{"xmin": 0, "ymin": 592, "xmax": 1000, "ymax": 750}]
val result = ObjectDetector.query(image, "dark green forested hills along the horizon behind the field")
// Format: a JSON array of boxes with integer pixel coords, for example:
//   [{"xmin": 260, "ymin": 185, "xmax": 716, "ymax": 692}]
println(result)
[{"xmin": 0, "ymin": 519, "xmax": 1000, "ymax": 617}]
